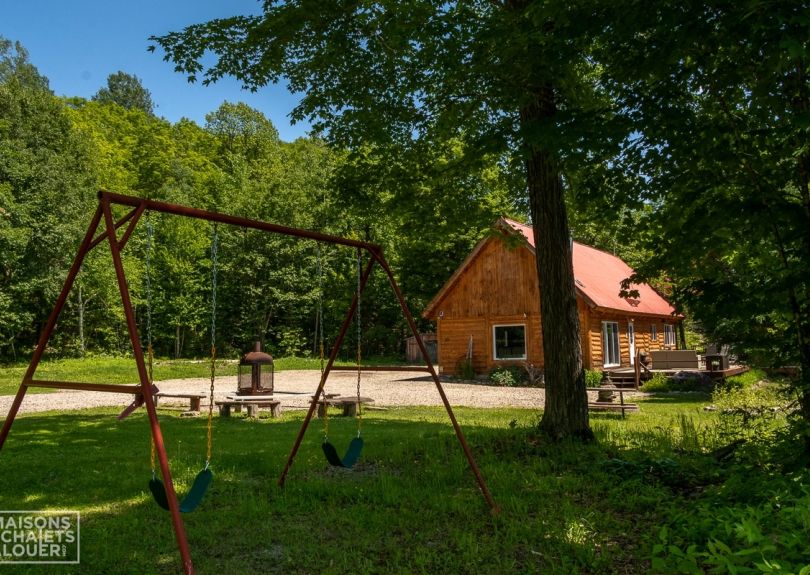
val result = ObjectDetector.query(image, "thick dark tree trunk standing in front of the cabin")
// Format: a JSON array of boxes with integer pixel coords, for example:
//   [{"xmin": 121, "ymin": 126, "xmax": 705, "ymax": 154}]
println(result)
[{"xmin": 520, "ymin": 86, "xmax": 593, "ymax": 440}]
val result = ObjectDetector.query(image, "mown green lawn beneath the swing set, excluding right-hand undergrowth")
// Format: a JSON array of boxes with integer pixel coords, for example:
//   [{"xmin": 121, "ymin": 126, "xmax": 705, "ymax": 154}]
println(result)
[{"xmin": 0, "ymin": 402, "xmax": 655, "ymax": 574}]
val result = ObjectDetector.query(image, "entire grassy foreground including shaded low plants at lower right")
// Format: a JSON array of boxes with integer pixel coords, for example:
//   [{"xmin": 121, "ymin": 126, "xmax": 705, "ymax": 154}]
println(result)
[{"xmin": 0, "ymin": 372, "xmax": 810, "ymax": 575}]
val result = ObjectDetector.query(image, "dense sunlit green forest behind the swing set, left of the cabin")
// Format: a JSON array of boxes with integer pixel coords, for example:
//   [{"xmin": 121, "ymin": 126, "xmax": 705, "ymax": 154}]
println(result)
[{"xmin": 0, "ymin": 41, "xmax": 518, "ymax": 360}]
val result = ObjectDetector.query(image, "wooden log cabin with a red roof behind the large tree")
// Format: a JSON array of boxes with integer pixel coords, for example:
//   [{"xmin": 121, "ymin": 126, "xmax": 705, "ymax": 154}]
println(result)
[{"xmin": 422, "ymin": 218, "xmax": 683, "ymax": 375}]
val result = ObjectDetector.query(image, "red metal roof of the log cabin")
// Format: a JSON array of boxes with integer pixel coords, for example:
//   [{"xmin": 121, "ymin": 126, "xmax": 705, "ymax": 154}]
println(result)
[{"xmin": 500, "ymin": 218, "xmax": 675, "ymax": 317}]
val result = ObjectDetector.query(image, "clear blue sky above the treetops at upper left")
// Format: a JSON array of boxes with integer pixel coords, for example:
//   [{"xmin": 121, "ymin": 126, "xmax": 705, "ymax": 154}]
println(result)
[{"xmin": 0, "ymin": 0, "xmax": 309, "ymax": 141}]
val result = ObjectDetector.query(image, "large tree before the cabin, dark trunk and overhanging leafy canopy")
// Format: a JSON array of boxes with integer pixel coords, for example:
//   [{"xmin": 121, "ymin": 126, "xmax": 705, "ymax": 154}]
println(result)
[{"xmin": 148, "ymin": 0, "xmax": 624, "ymax": 437}]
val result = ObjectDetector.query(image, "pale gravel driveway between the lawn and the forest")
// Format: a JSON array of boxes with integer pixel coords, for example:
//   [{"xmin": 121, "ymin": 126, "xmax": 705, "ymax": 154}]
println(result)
[{"xmin": 0, "ymin": 370, "xmax": 545, "ymax": 414}]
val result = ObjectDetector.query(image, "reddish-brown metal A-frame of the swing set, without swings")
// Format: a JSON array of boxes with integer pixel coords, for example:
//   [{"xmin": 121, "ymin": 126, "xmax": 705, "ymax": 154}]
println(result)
[{"xmin": 0, "ymin": 191, "xmax": 499, "ymax": 573}]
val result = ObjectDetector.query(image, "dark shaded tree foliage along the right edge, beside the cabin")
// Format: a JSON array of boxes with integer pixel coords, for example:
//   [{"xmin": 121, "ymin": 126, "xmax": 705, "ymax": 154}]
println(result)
[{"xmin": 592, "ymin": 1, "xmax": 810, "ymax": 446}]
